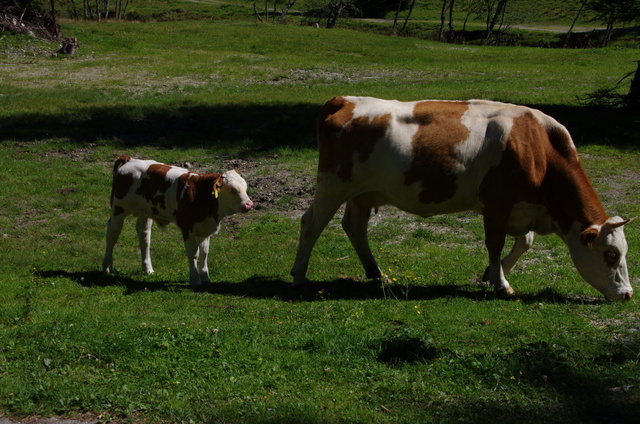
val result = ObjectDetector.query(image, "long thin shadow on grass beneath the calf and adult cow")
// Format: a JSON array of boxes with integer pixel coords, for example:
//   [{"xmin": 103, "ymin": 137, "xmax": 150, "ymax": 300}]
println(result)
[{"xmin": 36, "ymin": 270, "xmax": 606, "ymax": 305}]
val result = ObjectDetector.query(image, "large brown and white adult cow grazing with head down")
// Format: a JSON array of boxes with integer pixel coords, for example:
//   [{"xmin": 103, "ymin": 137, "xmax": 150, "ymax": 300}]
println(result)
[{"xmin": 291, "ymin": 97, "xmax": 633, "ymax": 300}]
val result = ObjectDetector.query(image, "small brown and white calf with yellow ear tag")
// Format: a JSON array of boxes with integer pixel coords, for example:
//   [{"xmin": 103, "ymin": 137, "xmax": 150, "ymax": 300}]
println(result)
[{"xmin": 102, "ymin": 156, "xmax": 253, "ymax": 287}]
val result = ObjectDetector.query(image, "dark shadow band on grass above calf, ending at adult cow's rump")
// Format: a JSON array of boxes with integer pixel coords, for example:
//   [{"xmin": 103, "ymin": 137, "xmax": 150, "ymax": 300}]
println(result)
[{"xmin": 0, "ymin": 103, "xmax": 320, "ymax": 154}]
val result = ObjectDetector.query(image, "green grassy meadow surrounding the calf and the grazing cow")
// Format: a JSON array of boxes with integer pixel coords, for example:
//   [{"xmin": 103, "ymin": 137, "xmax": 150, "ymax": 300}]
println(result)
[{"xmin": 0, "ymin": 7, "xmax": 640, "ymax": 423}]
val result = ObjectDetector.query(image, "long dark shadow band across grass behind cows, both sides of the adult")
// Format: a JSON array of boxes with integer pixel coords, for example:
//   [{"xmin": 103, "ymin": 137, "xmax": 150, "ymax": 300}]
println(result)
[{"xmin": 5, "ymin": 101, "xmax": 640, "ymax": 155}]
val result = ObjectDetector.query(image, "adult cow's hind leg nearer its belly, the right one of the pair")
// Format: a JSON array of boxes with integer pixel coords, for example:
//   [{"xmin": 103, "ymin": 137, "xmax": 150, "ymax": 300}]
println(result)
[{"xmin": 342, "ymin": 198, "xmax": 382, "ymax": 279}]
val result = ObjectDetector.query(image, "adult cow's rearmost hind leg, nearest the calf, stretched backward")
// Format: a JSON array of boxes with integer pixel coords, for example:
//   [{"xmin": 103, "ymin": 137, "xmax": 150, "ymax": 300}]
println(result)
[{"xmin": 291, "ymin": 195, "xmax": 342, "ymax": 287}]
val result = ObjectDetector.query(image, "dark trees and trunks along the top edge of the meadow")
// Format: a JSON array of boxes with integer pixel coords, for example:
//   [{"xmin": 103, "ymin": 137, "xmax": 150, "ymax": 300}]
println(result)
[{"xmin": 0, "ymin": 0, "xmax": 640, "ymax": 47}]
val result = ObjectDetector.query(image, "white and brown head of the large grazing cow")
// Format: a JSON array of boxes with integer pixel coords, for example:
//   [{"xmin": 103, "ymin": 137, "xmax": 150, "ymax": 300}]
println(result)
[{"xmin": 568, "ymin": 216, "xmax": 635, "ymax": 300}]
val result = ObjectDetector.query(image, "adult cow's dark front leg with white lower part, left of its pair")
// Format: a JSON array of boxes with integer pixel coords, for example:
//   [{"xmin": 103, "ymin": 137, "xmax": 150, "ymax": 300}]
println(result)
[{"xmin": 484, "ymin": 213, "xmax": 515, "ymax": 296}]
